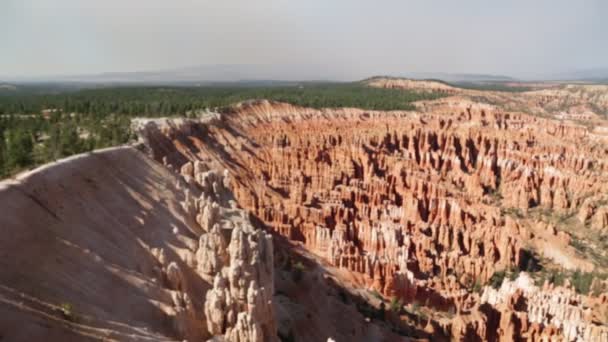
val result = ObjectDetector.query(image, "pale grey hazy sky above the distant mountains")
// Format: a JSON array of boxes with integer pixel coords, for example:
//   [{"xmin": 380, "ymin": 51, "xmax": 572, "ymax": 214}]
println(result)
[{"xmin": 0, "ymin": 0, "xmax": 608, "ymax": 79}]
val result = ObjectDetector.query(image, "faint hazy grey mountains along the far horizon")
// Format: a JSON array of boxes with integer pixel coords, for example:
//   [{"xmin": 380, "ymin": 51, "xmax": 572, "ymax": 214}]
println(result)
[{"xmin": 0, "ymin": 64, "xmax": 608, "ymax": 85}]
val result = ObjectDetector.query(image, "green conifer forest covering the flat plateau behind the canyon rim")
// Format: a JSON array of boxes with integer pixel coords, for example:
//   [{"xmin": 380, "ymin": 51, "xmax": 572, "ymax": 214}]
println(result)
[{"xmin": 0, "ymin": 83, "xmax": 443, "ymax": 178}]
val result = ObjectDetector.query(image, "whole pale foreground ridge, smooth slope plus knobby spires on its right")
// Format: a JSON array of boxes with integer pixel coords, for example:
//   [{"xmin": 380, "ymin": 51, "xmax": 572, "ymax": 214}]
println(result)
[{"xmin": 0, "ymin": 147, "xmax": 277, "ymax": 342}]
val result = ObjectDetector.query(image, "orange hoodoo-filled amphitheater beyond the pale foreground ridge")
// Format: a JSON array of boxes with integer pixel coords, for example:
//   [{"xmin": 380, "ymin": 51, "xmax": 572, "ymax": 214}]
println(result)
[{"xmin": 140, "ymin": 100, "xmax": 608, "ymax": 341}]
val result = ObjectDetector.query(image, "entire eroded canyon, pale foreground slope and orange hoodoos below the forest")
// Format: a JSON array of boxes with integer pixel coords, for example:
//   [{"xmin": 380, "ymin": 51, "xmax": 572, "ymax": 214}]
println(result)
[{"xmin": 0, "ymin": 79, "xmax": 608, "ymax": 341}]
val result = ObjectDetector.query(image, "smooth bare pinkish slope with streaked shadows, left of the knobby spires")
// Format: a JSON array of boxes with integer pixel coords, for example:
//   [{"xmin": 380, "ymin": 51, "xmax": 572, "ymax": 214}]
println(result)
[{"xmin": 0, "ymin": 147, "xmax": 194, "ymax": 341}]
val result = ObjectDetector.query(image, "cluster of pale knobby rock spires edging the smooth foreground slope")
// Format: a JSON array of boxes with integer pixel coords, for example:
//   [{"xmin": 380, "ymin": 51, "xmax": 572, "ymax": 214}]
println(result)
[{"xmin": 140, "ymin": 122, "xmax": 277, "ymax": 342}]
